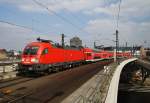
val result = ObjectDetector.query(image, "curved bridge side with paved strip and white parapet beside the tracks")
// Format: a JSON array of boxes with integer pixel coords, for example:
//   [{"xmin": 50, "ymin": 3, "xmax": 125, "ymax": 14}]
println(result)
[{"xmin": 62, "ymin": 58, "xmax": 150, "ymax": 103}]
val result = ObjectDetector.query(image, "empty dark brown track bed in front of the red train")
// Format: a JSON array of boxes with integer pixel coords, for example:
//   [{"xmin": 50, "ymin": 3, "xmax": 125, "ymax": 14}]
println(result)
[{"xmin": 0, "ymin": 60, "xmax": 111, "ymax": 103}]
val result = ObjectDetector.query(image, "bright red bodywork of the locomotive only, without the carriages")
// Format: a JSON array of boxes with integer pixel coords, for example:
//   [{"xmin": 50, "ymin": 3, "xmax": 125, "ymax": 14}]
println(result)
[{"xmin": 22, "ymin": 42, "xmax": 85, "ymax": 64}]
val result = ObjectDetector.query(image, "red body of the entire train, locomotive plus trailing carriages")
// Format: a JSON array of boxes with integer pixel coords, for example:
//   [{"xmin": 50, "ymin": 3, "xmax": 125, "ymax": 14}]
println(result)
[{"xmin": 21, "ymin": 42, "xmax": 131, "ymax": 65}]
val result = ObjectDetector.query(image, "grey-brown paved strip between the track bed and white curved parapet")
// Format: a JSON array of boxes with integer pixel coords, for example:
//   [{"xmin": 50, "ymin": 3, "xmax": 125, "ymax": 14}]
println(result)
[{"xmin": 61, "ymin": 63, "xmax": 115, "ymax": 103}]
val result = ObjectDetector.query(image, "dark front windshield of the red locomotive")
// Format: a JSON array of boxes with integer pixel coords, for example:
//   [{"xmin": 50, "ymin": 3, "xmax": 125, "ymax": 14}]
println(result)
[{"xmin": 23, "ymin": 46, "xmax": 39, "ymax": 55}]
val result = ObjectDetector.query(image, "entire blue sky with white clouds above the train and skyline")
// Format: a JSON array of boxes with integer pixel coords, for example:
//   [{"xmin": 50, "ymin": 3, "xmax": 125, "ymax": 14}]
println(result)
[{"xmin": 0, "ymin": 0, "xmax": 150, "ymax": 50}]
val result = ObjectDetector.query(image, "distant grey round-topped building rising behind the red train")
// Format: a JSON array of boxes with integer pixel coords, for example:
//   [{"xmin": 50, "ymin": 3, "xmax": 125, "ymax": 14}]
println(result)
[{"xmin": 70, "ymin": 37, "xmax": 82, "ymax": 48}]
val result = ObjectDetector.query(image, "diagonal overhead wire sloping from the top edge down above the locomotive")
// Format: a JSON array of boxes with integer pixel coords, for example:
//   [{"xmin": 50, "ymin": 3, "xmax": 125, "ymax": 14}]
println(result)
[{"xmin": 32, "ymin": 0, "xmax": 89, "ymax": 34}]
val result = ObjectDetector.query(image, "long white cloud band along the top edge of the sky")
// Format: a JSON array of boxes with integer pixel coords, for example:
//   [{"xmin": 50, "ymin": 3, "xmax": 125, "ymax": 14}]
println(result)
[{"xmin": 0, "ymin": 0, "xmax": 150, "ymax": 20}]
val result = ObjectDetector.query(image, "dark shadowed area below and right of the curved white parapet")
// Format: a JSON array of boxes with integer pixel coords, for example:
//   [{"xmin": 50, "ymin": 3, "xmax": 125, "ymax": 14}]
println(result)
[{"xmin": 117, "ymin": 62, "xmax": 150, "ymax": 103}]
